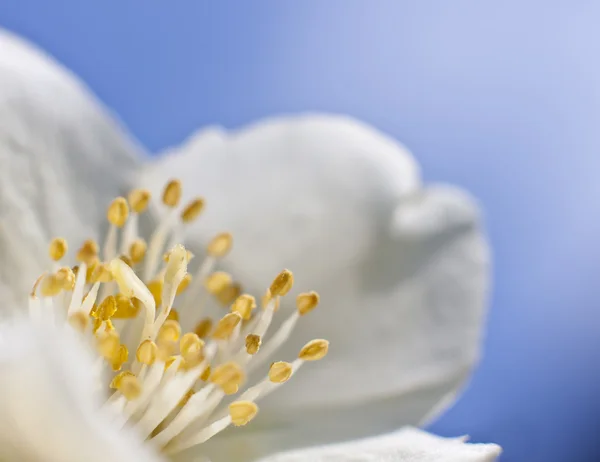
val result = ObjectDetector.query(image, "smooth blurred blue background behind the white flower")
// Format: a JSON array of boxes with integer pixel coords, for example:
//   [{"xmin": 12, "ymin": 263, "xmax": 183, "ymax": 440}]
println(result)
[{"xmin": 0, "ymin": 0, "xmax": 600, "ymax": 462}]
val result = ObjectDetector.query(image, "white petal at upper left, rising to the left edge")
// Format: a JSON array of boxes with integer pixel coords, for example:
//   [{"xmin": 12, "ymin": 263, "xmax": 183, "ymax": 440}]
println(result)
[{"xmin": 0, "ymin": 30, "xmax": 140, "ymax": 310}]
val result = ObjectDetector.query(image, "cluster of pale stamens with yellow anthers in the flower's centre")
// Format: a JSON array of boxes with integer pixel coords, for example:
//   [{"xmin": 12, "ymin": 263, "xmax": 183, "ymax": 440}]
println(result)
[{"xmin": 29, "ymin": 180, "xmax": 329, "ymax": 454}]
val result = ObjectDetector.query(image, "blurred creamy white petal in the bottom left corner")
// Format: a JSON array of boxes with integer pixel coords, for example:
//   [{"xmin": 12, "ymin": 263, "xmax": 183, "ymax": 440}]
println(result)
[{"xmin": 0, "ymin": 321, "xmax": 161, "ymax": 462}]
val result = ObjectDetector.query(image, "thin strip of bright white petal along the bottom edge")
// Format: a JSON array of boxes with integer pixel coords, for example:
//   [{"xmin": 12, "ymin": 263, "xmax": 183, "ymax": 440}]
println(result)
[{"xmin": 253, "ymin": 428, "xmax": 501, "ymax": 462}]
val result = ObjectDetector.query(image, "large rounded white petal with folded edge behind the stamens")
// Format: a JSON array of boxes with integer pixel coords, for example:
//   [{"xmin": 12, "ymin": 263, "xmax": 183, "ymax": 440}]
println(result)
[{"xmin": 144, "ymin": 116, "xmax": 489, "ymax": 454}]
